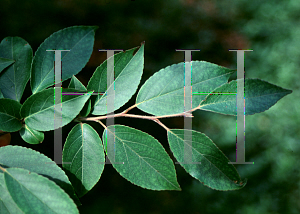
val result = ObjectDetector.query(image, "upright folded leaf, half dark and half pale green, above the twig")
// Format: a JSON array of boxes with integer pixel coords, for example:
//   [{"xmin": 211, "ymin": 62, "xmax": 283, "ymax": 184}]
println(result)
[{"xmin": 87, "ymin": 43, "xmax": 144, "ymax": 115}]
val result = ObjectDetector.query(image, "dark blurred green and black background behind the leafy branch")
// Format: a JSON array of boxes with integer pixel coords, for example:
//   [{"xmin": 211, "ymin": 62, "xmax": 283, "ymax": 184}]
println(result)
[{"xmin": 0, "ymin": 0, "xmax": 300, "ymax": 214}]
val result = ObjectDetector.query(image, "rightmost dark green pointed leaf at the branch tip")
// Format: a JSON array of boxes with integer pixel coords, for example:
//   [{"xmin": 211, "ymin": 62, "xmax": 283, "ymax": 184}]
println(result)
[{"xmin": 200, "ymin": 79, "xmax": 292, "ymax": 116}]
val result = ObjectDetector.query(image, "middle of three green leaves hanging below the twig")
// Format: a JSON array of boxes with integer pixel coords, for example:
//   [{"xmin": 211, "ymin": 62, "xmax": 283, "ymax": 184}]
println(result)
[{"xmin": 103, "ymin": 125, "xmax": 181, "ymax": 190}]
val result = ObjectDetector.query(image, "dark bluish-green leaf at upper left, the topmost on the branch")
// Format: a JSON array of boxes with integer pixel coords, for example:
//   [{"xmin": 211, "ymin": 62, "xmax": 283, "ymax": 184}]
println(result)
[{"xmin": 31, "ymin": 26, "xmax": 98, "ymax": 94}]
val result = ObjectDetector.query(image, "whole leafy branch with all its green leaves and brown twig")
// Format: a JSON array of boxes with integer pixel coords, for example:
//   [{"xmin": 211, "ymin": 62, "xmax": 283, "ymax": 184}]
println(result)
[{"xmin": 0, "ymin": 26, "xmax": 292, "ymax": 213}]
